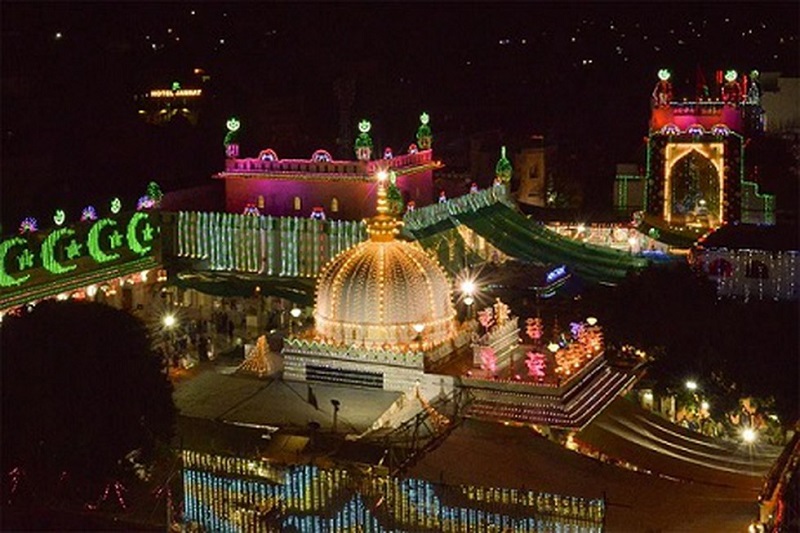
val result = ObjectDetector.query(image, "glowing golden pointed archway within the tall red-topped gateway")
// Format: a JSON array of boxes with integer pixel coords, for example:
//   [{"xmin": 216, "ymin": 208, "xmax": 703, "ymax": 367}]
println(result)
[{"xmin": 663, "ymin": 142, "xmax": 725, "ymax": 227}]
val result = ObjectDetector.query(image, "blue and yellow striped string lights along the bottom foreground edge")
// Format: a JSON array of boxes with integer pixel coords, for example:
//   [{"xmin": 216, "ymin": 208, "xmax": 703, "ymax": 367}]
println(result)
[{"xmin": 182, "ymin": 450, "xmax": 605, "ymax": 533}]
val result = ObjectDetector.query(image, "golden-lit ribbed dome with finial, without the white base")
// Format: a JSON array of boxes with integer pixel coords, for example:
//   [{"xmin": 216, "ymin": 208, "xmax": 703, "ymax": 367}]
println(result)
[{"xmin": 314, "ymin": 179, "xmax": 455, "ymax": 347}]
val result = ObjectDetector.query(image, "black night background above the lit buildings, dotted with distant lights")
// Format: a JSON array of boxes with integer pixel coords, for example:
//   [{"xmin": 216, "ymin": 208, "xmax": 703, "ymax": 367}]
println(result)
[{"xmin": 0, "ymin": 2, "xmax": 800, "ymax": 229}]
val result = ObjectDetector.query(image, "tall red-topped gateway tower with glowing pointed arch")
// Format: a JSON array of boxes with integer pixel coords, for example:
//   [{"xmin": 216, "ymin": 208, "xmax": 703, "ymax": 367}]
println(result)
[{"xmin": 645, "ymin": 69, "xmax": 775, "ymax": 228}]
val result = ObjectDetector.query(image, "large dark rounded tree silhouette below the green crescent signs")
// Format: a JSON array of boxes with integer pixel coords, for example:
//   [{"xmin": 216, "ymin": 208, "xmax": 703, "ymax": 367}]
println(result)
[{"xmin": 0, "ymin": 301, "xmax": 175, "ymax": 505}]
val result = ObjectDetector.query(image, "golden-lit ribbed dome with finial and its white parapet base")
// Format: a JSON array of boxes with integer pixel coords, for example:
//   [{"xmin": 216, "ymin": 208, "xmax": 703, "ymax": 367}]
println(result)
[{"xmin": 283, "ymin": 172, "xmax": 469, "ymax": 391}]
